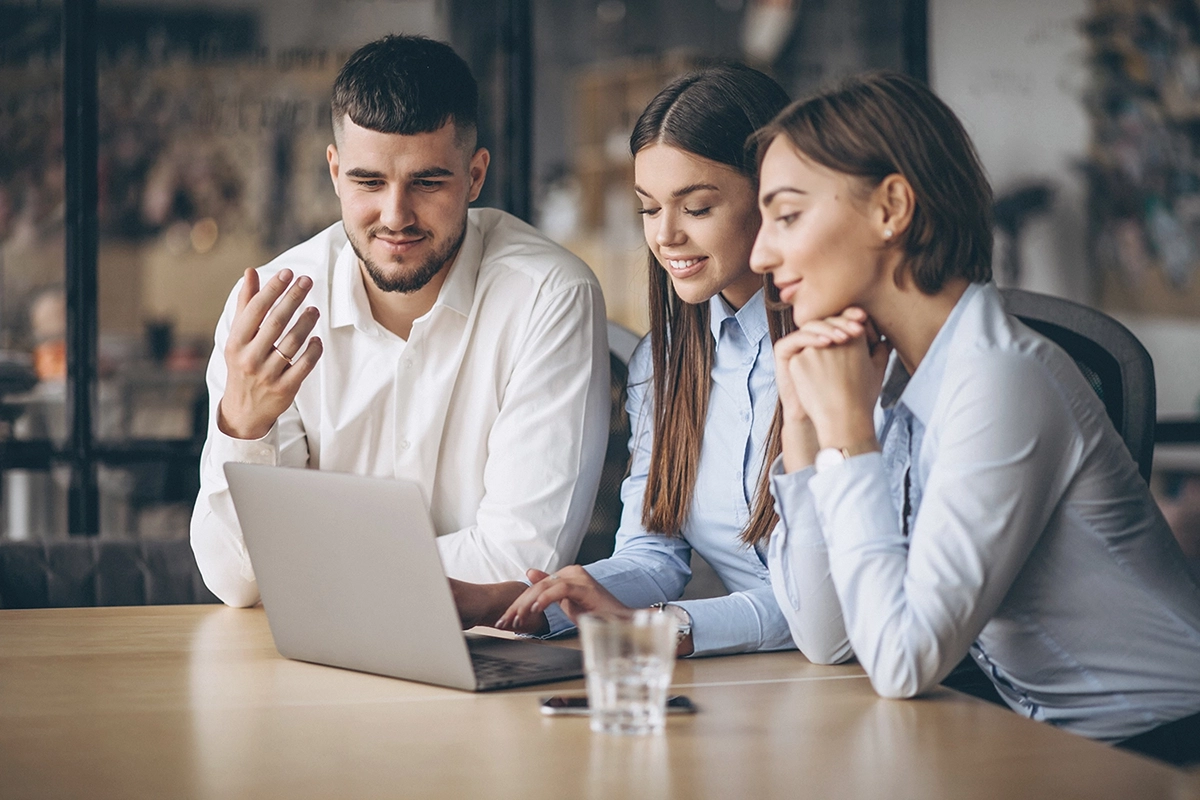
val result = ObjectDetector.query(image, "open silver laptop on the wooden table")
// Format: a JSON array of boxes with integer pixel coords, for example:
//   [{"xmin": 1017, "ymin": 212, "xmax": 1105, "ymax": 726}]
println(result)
[{"xmin": 224, "ymin": 463, "xmax": 583, "ymax": 691}]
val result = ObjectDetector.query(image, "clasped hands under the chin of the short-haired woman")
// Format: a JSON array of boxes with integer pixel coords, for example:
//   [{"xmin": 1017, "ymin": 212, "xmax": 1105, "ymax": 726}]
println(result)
[{"xmin": 775, "ymin": 307, "xmax": 892, "ymax": 473}]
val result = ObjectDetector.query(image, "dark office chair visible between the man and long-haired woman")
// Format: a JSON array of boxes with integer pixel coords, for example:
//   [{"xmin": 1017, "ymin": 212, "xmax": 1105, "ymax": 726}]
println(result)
[{"xmin": 575, "ymin": 320, "xmax": 641, "ymax": 564}]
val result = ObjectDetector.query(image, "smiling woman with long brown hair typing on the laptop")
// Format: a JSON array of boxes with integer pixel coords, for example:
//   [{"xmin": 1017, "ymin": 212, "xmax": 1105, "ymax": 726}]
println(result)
[{"xmin": 477, "ymin": 65, "xmax": 836, "ymax": 655}]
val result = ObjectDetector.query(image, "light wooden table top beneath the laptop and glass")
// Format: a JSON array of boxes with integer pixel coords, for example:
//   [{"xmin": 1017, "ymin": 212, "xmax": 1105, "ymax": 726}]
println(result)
[{"xmin": 0, "ymin": 606, "xmax": 1200, "ymax": 800}]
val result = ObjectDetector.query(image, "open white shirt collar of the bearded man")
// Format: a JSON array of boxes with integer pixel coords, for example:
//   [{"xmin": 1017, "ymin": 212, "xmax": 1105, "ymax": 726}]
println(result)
[{"xmin": 329, "ymin": 217, "xmax": 484, "ymax": 332}]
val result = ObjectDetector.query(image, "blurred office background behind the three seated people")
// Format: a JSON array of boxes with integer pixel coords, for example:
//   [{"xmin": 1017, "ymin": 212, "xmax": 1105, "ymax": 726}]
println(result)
[{"xmin": 0, "ymin": 0, "xmax": 1200, "ymax": 575}]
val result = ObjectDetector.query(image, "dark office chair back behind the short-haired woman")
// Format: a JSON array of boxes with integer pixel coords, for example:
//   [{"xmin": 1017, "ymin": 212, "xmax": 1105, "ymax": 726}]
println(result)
[{"xmin": 1000, "ymin": 289, "xmax": 1156, "ymax": 483}]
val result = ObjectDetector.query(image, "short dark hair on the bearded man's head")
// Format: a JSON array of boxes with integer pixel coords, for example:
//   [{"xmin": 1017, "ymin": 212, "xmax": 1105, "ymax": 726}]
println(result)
[{"xmin": 331, "ymin": 36, "xmax": 479, "ymax": 143}]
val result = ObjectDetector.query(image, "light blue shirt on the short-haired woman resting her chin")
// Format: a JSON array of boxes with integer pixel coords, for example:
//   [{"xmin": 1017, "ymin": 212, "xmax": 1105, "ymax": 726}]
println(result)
[{"xmin": 770, "ymin": 284, "xmax": 1200, "ymax": 741}]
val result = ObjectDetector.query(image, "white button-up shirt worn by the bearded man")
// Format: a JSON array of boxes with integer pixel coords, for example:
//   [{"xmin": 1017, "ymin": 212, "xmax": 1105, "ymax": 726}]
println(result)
[{"xmin": 192, "ymin": 209, "xmax": 610, "ymax": 606}]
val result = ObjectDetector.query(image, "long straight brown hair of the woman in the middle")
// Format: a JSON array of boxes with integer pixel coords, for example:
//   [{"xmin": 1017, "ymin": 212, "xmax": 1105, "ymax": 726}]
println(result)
[{"xmin": 629, "ymin": 64, "xmax": 792, "ymax": 545}]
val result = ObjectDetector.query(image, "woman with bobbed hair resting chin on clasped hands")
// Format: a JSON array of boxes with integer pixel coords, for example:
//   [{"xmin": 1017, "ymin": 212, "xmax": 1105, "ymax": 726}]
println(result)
[{"xmin": 750, "ymin": 73, "xmax": 1200, "ymax": 763}]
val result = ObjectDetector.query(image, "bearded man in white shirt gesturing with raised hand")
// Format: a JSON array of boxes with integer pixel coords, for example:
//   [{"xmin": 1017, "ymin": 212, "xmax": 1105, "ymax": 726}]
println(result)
[{"xmin": 192, "ymin": 36, "xmax": 608, "ymax": 606}]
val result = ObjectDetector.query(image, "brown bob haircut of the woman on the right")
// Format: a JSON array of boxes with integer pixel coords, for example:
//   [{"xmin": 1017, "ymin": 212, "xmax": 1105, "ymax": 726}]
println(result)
[{"xmin": 750, "ymin": 72, "xmax": 991, "ymax": 295}]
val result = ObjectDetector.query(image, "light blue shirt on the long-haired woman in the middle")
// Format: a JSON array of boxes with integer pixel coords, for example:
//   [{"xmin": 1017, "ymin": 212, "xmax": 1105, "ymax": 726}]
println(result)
[{"xmin": 546, "ymin": 291, "xmax": 794, "ymax": 655}]
